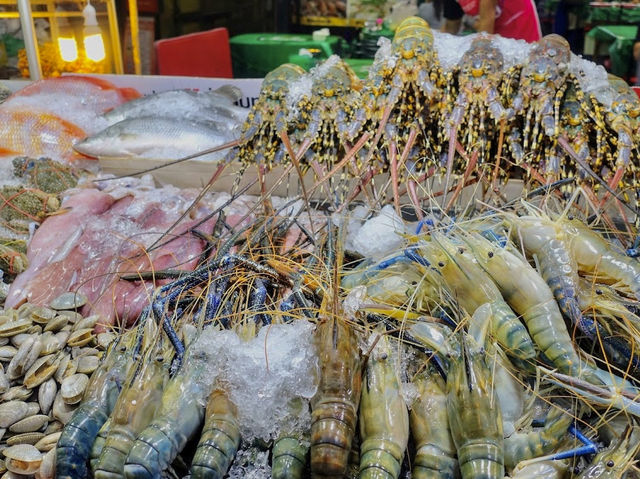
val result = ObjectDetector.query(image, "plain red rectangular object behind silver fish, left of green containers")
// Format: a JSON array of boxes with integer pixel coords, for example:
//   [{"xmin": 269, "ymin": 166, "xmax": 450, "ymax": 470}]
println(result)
[{"xmin": 155, "ymin": 28, "xmax": 233, "ymax": 78}]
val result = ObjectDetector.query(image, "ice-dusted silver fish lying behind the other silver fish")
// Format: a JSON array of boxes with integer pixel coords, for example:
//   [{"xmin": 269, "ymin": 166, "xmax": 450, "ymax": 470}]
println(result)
[{"xmin": 103, "ymin": 85, "xmax": 248, "ymax": 125}]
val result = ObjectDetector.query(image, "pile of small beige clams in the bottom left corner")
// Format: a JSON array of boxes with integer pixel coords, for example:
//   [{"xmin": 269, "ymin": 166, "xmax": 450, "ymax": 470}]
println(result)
[{"xmin": 0, "ymin": 293, "xmax": 114, "ymax": 478}]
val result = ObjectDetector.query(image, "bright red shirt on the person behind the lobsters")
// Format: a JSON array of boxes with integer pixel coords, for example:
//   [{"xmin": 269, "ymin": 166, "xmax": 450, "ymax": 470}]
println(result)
[{"xmin": 457, "ymin": 0, "xmax": 542, "ymax": 42}]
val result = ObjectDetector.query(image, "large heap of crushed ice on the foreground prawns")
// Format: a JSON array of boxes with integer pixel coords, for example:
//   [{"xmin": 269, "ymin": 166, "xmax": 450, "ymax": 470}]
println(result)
[{"xmin": 192, "ymin": 320, "xmax": 319, "ymax": 442}]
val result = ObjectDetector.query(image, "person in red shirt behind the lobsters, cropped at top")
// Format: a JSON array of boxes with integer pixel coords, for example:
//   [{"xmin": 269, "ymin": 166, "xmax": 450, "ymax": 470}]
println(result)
[{"xmin": 443, "ymin": 0, "xmax": 542, "ymax": 42}]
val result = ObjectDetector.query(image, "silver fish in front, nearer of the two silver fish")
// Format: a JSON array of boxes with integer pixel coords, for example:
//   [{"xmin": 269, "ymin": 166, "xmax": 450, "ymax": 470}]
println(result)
[{"xmin": 74, "ymin": 117, "xmax": 239, "ymax": 161}]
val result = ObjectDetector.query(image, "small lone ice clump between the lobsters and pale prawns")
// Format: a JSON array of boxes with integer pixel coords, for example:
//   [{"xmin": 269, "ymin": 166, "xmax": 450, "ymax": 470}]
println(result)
[{"xmin": 352, "ymin": 205, "xmax": 406, "ymax": 258}]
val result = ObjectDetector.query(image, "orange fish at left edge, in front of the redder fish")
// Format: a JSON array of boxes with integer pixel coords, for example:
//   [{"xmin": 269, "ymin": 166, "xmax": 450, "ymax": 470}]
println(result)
[{"xmin": 0, "ymin": 109, "xmax": 86, "ymax": 161}]
